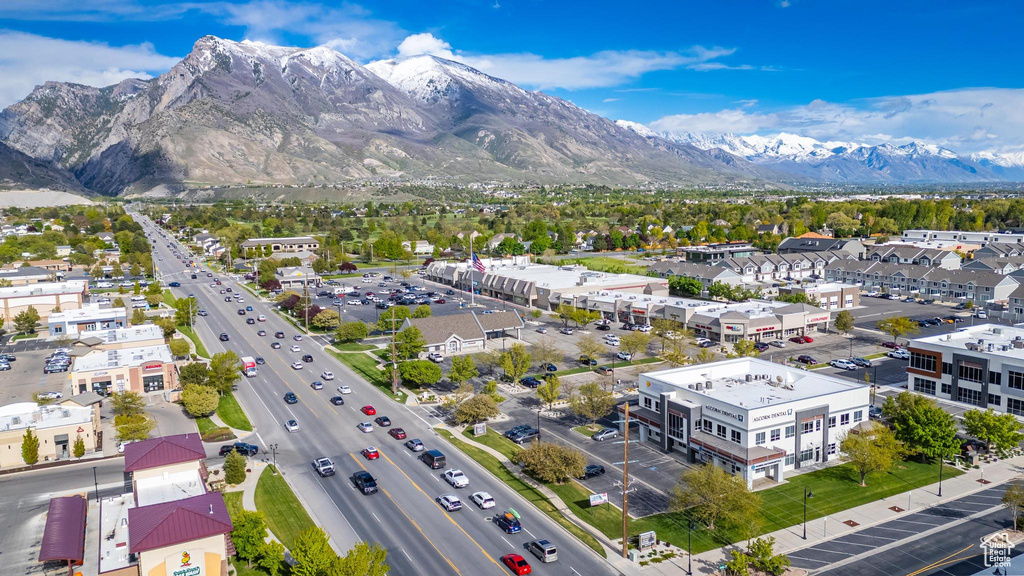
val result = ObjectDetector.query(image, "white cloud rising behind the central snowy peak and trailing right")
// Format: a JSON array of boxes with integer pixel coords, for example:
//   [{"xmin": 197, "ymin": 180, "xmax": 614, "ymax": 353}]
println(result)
[{"xmin": 389, "ymin": 33, "xmax": 741, "ymax": 90}]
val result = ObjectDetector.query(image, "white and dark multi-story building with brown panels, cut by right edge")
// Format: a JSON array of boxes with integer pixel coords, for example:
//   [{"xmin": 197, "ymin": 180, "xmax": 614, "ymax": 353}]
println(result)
[{"xmin": 906, "ymin": 324, "xmax": 1024, "ymax": 416}]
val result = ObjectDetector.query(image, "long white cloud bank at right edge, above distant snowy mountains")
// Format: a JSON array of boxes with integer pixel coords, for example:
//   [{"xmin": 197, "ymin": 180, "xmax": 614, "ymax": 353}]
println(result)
[{"xmin": 651, "ymin": 88, "xmax": 1024, "ymax": 154}]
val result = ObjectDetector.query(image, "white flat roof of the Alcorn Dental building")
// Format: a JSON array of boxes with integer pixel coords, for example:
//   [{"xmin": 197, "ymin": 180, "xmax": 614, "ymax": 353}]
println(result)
[{"xmin": 641, "ymin": 358, "xmax": 863, "ymax": 410}]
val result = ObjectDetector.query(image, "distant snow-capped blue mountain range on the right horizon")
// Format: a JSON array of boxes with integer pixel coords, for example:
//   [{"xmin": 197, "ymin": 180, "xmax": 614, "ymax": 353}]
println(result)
[{"xmin": 618, "ymin": 120, "xmax": 1024, "ymax": 184}]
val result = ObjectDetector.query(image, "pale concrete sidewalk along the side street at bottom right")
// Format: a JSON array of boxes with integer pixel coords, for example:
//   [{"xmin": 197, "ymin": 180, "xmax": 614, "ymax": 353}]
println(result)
[{"xmin": 693, "ymin": 456, "xmax": 1024, "ymax": 574}]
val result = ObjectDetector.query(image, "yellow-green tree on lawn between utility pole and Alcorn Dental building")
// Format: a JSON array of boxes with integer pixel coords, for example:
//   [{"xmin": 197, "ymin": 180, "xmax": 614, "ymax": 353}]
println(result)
[{"xmin": 670, "ymin": 463, "xmax": 760, "ymax": 530}]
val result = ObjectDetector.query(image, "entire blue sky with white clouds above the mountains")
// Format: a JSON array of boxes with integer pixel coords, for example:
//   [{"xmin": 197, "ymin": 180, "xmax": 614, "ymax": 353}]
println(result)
[{"xmin": 0, "ymin": 0, "xmax": 1024, "ymax": 152}]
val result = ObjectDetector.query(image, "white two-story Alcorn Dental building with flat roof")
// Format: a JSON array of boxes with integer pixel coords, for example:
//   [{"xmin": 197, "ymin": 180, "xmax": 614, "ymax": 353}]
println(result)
[{"xmin": 620, "ymin": 358, "xmax": 869, "ymax": 487}]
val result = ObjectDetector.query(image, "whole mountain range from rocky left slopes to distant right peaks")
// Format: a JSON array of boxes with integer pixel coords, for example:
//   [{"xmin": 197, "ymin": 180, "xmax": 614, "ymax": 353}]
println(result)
[{"xmin": 0, "ymin": 36, "xmax": 1024, "ymax": 195}]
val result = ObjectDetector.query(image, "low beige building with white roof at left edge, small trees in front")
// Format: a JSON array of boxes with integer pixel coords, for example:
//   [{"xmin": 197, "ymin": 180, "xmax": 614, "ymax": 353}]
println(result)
[{"xmin": 0, "ymin": 400, "xmax": 100, "ymax": 468}]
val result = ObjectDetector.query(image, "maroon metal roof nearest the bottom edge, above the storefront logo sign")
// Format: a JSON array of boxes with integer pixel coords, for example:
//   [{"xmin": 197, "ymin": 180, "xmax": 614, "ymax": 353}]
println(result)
[{"xmin": 128, "ymin": 492, "xmax": 233, "ymax": 553}]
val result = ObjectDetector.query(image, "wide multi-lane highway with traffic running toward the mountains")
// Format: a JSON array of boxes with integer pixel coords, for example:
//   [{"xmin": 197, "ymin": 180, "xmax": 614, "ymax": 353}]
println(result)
[{"xmin": 132, "ymin": 213, "xmax": 617, "ymax": 576}]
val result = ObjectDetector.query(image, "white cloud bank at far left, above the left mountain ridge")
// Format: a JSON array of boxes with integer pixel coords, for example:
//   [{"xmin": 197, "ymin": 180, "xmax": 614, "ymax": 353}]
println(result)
[{"xmin": 0, "ymin": 31, "xmax": 180, "ymax": 107}]
